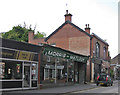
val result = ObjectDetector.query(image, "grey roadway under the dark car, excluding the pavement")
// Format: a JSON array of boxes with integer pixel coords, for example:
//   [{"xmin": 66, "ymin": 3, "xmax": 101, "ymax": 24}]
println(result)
[{"xmin": 72, "ymin": 83, "xmax": 118, "ymax": 93}]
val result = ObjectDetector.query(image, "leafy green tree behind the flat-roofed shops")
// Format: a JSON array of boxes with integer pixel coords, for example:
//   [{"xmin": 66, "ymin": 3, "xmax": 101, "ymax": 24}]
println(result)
[{"xmin": 2, "ymin": 23, "xmax": 46, "ymax": 42}]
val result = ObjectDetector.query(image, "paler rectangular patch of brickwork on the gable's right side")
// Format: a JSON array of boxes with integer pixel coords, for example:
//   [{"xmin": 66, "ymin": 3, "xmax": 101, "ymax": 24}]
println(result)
[{"xmin": 69, "ymin": 36, "xmax": 90, "ymax": 56}]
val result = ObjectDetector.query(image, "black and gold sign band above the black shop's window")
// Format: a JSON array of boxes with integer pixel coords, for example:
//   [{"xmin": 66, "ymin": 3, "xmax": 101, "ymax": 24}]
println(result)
[{"xmin": 0, "ymin": 49, "xmax": 38, "ymax": 61}]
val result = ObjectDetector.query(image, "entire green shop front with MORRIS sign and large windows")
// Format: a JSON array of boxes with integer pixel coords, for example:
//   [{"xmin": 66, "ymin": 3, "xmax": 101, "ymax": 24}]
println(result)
[{"xmin": 40, "ymin": 45, "xmax": 88, "ymax": 86}]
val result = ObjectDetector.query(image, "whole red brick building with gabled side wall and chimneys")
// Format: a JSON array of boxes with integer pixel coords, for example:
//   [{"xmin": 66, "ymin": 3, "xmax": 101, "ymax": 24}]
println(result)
[{"xmin": 29, "ymin": 10, "xmax": 109, "ymax": 81}]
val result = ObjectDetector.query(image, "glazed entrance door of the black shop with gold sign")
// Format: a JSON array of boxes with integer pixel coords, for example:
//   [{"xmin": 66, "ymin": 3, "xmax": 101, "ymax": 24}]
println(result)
[{"xmin": 23, "ymin": 65, "xmax": 31, "ymax": 88}]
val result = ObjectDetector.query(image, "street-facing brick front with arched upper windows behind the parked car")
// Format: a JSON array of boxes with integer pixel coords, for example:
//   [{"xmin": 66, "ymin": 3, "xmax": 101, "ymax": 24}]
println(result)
[{"xmin": 90, "ymin": 33, "xmax": 110, "ymax": 80}]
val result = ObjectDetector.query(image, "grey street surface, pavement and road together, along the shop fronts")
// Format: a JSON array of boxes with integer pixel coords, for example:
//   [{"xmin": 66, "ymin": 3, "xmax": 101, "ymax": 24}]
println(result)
[{"xmin": 2, "ymin": 81, "xmax": 120, "ymax": 95}]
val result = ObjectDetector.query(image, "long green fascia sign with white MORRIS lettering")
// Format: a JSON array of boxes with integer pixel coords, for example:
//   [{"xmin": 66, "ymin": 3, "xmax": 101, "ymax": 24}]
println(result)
[{"xmin": 43, "ymin": 48, "xmax": 88, "ymax": 63}]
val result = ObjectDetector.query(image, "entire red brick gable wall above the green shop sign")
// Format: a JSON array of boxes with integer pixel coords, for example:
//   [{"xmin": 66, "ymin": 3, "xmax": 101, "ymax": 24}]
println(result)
[{"xmin": 48, "ymin": 24, "xmax": 90, "ymax": 55}]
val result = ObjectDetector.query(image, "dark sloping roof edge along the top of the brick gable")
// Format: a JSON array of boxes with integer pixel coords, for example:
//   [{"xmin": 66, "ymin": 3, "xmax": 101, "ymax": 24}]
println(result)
[{"xmin": 45, "ymin": 21, "xmax": 92, "ymax": 41}]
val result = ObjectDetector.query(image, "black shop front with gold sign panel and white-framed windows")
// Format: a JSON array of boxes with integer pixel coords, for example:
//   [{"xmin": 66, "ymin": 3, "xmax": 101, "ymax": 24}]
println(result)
[{"xmin": 0, "ymin": 39, "xmax": 40, "ymax": 91}]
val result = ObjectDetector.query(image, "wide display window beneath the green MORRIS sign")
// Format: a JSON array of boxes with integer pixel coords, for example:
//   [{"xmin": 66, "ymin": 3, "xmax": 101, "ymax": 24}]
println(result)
[{"xmin": 42, "ymin": 55, "xmax": 74, "ymax": 83}]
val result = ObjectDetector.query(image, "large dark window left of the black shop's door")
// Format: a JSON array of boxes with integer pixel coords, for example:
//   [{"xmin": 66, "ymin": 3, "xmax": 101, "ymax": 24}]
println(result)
[{"xmin": 0, "ymin": 61, "xmax": 22, "ymax": 79}]
